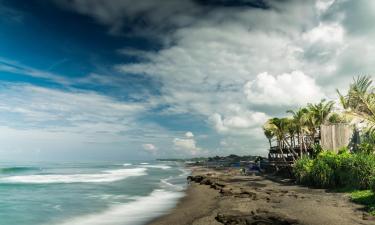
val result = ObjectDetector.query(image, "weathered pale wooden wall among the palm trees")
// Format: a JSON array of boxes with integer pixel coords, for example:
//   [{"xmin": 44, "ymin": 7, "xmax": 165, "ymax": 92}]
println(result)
[{"xmin": 321, "ymin": 124, "xmax": 353, "ymax": 152}]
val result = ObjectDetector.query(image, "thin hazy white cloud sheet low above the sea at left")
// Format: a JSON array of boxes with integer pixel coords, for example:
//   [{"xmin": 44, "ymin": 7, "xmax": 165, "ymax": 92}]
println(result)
[{"xmin": 0, "ymin": 84, "xmax": 172, "ymax": 157}]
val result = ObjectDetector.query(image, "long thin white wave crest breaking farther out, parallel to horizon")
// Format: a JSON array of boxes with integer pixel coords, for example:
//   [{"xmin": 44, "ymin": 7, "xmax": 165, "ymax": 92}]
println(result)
[{"xmin": 0, "ymin": 168, "xmax": 147, "ymax": 184}]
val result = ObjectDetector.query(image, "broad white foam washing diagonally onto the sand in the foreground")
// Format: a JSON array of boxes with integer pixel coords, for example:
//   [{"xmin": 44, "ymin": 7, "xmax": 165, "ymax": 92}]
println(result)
[{"xmin": 56, "ymin": 190, "xmax": 184, "ymax": 225}]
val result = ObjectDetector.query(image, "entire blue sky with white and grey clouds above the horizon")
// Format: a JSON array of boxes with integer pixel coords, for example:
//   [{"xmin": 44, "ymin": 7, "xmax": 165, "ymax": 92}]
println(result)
[{"xmin": 0, "ymin": 0, "xmax": 375, "ymax": 160}]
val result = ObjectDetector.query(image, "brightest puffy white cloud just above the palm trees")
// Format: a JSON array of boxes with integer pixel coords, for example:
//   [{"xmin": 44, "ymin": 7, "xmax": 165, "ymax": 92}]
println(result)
[{"xmin": 244, "ymin": 71, "xmax": 324, "ymax": 106}]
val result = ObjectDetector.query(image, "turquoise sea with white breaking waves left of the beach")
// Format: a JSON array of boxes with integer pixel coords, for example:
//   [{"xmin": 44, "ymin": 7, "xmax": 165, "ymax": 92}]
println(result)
[{"xmin": 0, "ymin": 162, "xmax": 188, "ymax": 225}]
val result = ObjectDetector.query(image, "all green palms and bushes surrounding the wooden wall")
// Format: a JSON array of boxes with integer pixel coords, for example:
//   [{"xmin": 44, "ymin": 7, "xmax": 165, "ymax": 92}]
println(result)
[{"xmin": 263, "ymin": 76, "xmax": 375, "ymax": 216}]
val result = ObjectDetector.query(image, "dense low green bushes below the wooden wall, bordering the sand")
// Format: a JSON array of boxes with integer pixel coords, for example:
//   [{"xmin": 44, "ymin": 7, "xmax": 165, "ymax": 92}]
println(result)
[{"xmin": 293, "ymin": 149, "xmax": 375, "ymax": 190}]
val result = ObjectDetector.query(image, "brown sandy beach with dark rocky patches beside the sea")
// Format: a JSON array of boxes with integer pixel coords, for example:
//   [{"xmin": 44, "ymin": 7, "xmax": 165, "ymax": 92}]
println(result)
[{"xmin": 148, "ymin": 167, "xmax": 375, "ymax": 225}]
